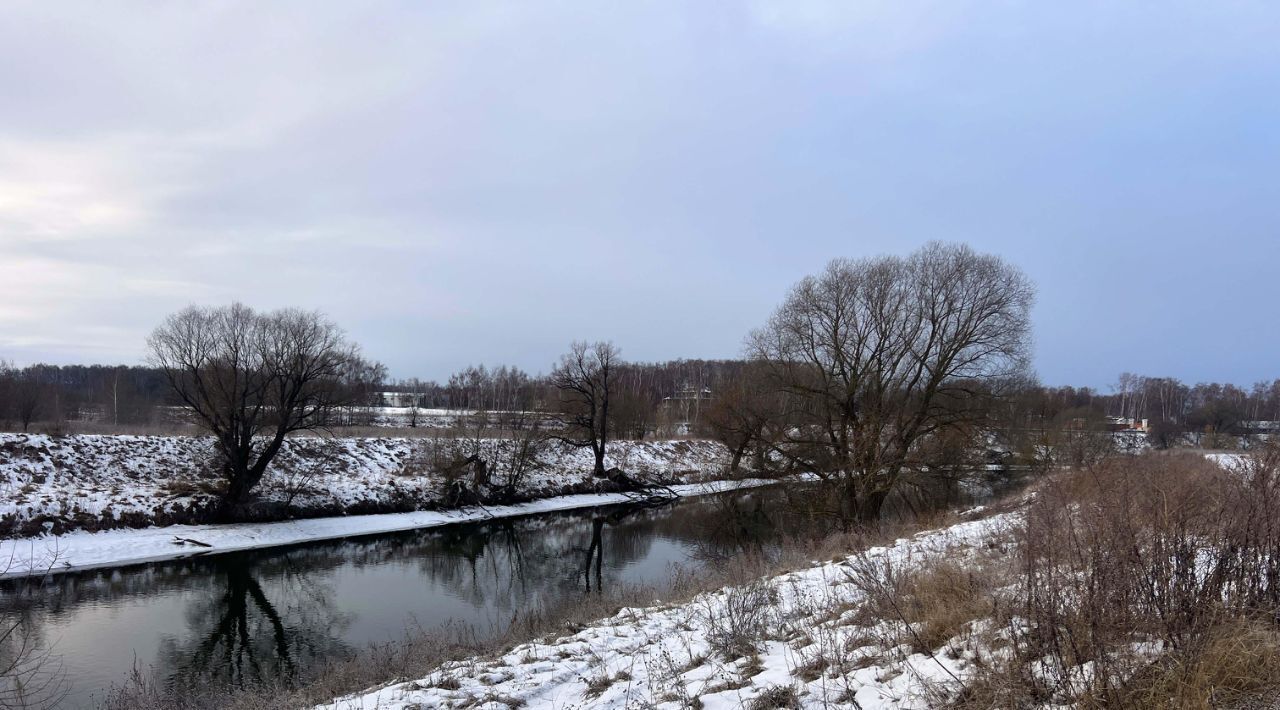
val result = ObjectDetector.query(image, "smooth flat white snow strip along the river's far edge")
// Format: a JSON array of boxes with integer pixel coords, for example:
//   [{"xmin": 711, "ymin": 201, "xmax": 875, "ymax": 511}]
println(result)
[{"xmin": 0, "ymin": 478, "xmax": 774, "ymax": 578}]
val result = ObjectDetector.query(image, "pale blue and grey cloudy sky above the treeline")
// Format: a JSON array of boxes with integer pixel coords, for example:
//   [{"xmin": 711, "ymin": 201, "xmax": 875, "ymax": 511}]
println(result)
[{"xmin": 0, "ymin": 0, "xmax": 1280, "ymax": 388}]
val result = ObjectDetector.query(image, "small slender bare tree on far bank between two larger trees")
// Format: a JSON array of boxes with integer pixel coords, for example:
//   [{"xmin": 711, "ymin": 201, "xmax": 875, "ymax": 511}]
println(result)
[{"xmin": 550, "ymin": 342, "xmax": 621, "ymax": 478}]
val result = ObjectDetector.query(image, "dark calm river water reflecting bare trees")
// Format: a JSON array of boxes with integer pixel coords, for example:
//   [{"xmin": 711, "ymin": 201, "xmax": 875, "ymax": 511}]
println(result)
[{"xmin": 0, "ymin": 489, "xmax": 798, "ymax": 707}]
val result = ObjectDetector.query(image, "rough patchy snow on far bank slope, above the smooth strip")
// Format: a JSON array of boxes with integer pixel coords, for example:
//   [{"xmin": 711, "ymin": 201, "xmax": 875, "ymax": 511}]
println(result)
[{"xmin": 0, "ymin": 434, "xmax": 727, "ymax": 536}]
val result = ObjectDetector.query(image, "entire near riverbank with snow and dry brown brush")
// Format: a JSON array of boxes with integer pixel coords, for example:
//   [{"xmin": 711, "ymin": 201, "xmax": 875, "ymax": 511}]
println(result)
[{"xmin": 304, "ymin": 450, "xmax": 1280, "ymax": 710}]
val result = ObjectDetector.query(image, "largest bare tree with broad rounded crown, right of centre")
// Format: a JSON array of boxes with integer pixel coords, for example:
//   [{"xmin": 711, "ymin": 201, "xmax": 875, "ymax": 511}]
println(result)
[{"xmin": 749, "ymin": 243, "xmax": 1034, "ymax": 519}]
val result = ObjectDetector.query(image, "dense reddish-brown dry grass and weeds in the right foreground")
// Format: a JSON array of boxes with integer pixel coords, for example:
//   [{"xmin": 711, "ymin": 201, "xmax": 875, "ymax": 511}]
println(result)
[{"xmin": 956, "ymin": 449, "xmax": 1280, "ymax": 709}]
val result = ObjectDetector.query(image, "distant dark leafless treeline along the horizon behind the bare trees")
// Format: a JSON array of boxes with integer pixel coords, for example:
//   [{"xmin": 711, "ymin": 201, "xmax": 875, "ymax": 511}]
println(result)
[{"xmin": 0, "ymin": 359, "xmax": 1280, "ymax": 445}]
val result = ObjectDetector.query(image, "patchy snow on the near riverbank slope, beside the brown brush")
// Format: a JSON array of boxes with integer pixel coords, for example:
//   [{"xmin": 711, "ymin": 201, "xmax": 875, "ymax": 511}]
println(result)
[{"xmin": 317, "ymin": 514, "xmax": 1014, "ymax": 710}]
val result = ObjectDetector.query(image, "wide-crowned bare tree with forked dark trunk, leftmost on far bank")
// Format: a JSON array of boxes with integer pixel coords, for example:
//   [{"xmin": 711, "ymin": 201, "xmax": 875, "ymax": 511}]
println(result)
[{"xmin": 148, "ymin": 303, "xmax": 381, "ymax": 505}]
